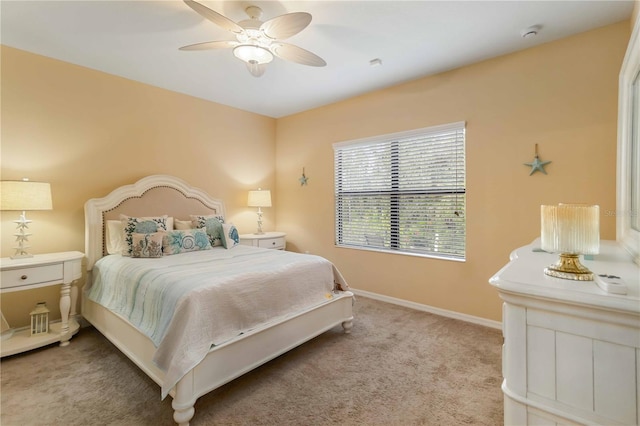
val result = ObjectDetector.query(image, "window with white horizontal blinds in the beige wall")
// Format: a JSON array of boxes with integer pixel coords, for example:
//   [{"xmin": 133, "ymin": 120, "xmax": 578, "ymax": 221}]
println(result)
[{"xmin": 334, "ymin": 122, "xmax": 466, "ymax": 260}]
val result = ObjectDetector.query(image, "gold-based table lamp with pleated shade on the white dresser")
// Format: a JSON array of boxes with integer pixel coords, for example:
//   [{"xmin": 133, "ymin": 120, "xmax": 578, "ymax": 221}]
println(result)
[{"xmin": 540, "ymin": 204, "xmax": 600, "ymax": 281}]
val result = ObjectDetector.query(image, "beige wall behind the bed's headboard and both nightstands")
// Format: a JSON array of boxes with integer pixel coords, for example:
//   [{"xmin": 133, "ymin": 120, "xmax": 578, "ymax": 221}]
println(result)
[{"xmin": 0, "ymin": 46, "xmax": 277, "ymax": 326}]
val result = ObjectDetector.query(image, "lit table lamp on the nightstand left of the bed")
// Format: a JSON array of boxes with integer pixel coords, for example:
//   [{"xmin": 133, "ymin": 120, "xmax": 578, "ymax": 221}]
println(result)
[{"xmin": 0, "ymin": 179, "xmax": 53, "ymax": 259}]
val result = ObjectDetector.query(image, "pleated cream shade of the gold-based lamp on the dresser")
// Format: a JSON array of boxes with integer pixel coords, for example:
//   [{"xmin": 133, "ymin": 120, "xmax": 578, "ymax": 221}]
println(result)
[{"xmin": 540, "ymin": 204, "xmax": 600, "ymax": 254}]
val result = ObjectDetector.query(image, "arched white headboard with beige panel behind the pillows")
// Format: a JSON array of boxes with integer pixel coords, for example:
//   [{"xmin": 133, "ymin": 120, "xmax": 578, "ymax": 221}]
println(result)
[{"xmin": 84, "ymin": 175, "xmax": 225, "ymax": 271}]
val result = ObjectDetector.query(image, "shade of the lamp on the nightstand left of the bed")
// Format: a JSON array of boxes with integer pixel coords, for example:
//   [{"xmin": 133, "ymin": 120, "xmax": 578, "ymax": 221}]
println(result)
[{"xmin": 0, "ymin": 180, "xmax": 53, "ymax": 211}]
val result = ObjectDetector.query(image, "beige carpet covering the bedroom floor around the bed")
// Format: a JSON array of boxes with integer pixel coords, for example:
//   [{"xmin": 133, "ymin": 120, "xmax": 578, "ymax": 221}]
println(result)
[{"xmin": 0, "ymin": 297, "xmax": 503, "ymax": 426}]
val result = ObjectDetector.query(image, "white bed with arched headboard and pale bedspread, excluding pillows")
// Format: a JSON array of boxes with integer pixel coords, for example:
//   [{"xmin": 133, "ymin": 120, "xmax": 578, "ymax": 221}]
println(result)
[{"xmin": 82, "ymin": 175, "xmax": 354, "ymax": 425}]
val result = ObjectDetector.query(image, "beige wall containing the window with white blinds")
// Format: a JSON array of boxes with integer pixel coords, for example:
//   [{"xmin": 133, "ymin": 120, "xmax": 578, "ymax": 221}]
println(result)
[{"xmin": 276, "ymin": 21, "xmax": 630, "ymax": 320}]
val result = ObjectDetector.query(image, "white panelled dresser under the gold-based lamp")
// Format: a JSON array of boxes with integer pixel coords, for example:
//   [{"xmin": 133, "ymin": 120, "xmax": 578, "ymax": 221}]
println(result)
[{"xmin": 489, "ymin": 240, "xmax": 640, "ymax": 425}]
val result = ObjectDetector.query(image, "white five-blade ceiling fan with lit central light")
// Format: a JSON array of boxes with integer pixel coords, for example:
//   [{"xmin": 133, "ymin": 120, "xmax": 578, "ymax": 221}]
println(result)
[{"xmin": 180, "ymin": 0, "xmax": 327, "ymax": 77}]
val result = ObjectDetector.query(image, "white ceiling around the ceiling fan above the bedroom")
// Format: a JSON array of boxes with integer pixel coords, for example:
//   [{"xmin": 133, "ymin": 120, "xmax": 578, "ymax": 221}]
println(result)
[{"xmin": 0, "ymin": 0, "xmax": 633, "ymax": 118}]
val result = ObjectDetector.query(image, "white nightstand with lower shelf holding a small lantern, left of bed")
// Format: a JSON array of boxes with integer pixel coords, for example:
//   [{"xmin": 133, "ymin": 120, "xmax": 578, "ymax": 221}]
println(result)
[{"xmin": 0, "ymin": 251, "xmax": 84, "ymax": 357}]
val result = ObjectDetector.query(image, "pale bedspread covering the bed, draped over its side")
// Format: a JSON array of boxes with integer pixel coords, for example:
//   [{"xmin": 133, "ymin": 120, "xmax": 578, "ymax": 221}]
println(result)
[{"xmin": 87, "ymin": 245, "xmax": 348, "ymax": 398}]
